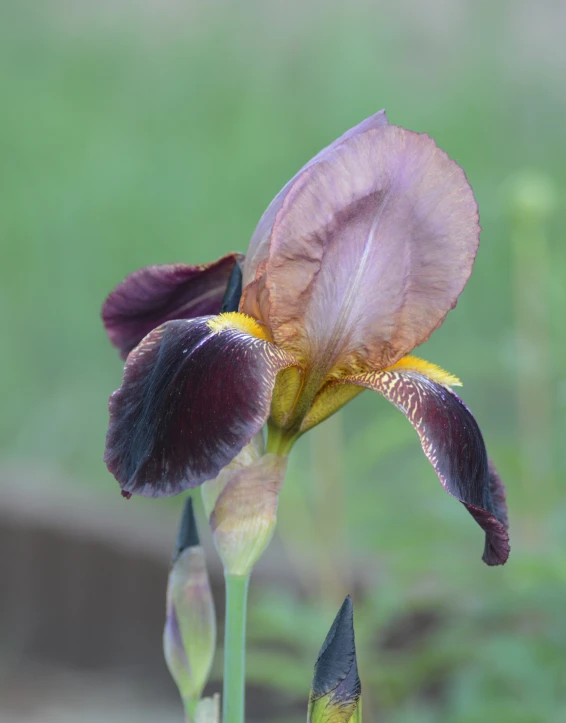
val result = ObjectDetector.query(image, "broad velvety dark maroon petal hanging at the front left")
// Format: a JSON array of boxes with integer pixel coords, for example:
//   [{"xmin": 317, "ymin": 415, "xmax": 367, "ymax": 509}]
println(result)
[{"xmin": 105, "ymin": 317, "xmax": 294, "ymax": 497}]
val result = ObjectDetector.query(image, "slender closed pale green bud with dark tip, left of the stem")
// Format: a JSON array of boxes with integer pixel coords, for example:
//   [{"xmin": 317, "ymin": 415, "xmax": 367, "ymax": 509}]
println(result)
[{"xmin": 163, "ymin": 497, "xmax": 216, "ymax": 720}]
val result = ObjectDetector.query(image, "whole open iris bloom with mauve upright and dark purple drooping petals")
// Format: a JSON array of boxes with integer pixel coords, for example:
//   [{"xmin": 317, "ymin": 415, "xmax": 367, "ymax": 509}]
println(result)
[{"xmin": 102, "ymin": 111, "xmax": 509, "ymax": 565}]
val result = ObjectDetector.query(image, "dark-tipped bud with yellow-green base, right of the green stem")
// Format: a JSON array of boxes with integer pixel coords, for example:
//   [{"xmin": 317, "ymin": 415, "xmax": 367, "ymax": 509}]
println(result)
[{"xmin": 308, "ymin": 595, "xmax": 362, "ymax": 723}]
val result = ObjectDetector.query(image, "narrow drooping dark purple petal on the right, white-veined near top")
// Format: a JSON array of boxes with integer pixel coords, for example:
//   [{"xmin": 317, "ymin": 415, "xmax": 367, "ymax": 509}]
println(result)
[{"xmin": 348, "ymin": 369, "xmax": 509, "ymax": 565}]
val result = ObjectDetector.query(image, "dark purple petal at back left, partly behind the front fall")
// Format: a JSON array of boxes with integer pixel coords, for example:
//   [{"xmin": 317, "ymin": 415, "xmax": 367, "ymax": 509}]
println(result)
[{"xmin": 102, "ymin": 253, "xmax": 244, "ymax": 359}]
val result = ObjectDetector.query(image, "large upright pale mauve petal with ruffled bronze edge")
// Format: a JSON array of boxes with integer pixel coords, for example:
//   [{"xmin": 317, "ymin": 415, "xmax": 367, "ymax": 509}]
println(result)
[{"xmin": 240, "ymin": 125, "xmax": 480, "ymax": 372}]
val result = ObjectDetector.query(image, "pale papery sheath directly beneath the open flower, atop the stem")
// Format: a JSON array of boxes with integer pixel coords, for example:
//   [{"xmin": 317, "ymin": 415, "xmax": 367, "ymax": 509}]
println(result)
[{"xmin": 202, "ymin": 436, "xmax": 287, "ymax": 576}]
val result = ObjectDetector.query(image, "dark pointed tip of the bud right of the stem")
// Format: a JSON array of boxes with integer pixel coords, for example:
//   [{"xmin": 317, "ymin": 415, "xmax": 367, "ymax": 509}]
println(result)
[{"xmin": 312, "ymin": 595, "xmax": 357, "ymax": 698}]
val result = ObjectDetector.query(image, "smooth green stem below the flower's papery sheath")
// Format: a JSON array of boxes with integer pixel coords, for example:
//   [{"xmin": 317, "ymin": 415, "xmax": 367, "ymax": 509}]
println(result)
[{"xmin": 222, "ymin": 575, "xmax": 250, "ymax": 723}]
